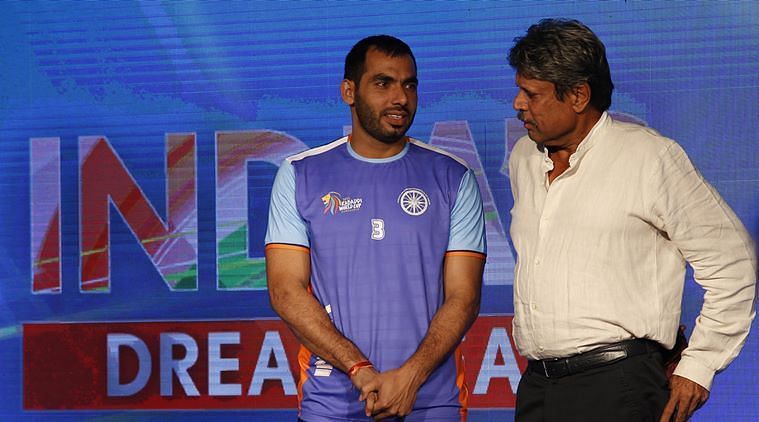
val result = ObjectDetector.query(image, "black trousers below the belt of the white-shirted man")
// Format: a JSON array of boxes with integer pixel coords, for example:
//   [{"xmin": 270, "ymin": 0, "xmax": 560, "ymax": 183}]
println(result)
[{"xmin": 515, "ymin": 352, "xmax": 669, "ymax": 422}]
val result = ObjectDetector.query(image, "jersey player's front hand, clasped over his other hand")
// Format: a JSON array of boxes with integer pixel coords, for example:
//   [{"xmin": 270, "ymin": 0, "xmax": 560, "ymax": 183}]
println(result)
[{"xmin": 361, "ymin": 367, "xmax": 421, "ymax": 421}]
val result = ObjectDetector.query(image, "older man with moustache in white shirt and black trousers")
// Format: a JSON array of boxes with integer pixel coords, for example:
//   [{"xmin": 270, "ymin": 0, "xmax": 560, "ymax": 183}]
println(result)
[{"xmin": 509, "ymin": 19, "xmax": 757, "ymax": 421}]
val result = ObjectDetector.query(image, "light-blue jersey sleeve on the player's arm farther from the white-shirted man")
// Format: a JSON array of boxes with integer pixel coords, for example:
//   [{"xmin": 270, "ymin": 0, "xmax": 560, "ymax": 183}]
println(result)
[{"xmin": 265, "ymin": 160, "xmax": 310, "ymax": 247}]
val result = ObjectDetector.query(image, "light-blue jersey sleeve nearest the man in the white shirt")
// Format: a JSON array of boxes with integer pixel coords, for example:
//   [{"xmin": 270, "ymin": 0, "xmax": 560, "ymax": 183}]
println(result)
[{"xmin": 448, "ymin": 170, "xmax": 487, "ymax": 254}]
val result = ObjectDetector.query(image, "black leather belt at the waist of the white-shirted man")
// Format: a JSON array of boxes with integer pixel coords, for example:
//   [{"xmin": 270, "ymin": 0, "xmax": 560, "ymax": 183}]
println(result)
[{"xmin": 527, "ymin": 339, "xmax": 662, "ymax": 378}]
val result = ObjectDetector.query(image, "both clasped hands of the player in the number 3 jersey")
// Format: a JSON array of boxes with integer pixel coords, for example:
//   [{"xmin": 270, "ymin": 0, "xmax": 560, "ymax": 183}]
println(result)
[{"xmin": 351, "ymin": 367, "xmax": 423, "ymax": 421}]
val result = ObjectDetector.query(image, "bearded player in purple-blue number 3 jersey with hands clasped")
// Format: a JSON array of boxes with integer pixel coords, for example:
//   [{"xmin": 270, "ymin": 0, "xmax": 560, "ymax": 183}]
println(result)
[{"xmin": 266, "ymin": 35, "xmax": 485, "ymax": 422}]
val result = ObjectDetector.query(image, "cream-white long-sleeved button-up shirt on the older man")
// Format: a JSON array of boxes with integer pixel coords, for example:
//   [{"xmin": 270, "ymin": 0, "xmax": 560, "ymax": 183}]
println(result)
[{"xmin": 509, "ymin": 113, "xmax": 757, "ymax": 389}]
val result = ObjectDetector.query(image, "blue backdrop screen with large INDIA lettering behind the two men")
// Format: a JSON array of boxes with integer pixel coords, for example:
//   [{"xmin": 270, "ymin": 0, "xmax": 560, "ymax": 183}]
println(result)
[{"xmin": 0, "ymin": 1, "xmax": 759, "ymax": 421}]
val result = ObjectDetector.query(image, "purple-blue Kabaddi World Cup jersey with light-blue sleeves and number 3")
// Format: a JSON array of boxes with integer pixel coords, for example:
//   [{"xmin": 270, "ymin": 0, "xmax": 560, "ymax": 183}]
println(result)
[{"xmin": 266, "ymin": 137, "xmax": 485, "ymax": 422}]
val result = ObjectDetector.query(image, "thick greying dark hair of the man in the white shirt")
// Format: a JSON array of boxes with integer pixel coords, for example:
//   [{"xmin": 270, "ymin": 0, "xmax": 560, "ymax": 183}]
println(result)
[{"xmin": 509, "ymin": 19, "xmax": 614, "ymax": 111}]
